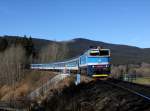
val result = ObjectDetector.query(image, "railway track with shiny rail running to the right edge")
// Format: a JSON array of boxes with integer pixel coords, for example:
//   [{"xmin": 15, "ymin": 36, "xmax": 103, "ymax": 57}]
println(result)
[{"xmin": 104, "ymin": 79, "xmax": 150, "ymax": 102}]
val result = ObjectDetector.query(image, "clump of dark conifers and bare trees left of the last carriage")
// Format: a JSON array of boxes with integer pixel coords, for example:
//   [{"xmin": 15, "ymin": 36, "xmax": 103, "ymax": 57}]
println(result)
[{"xmin": 0, "ymin": 36, "xmax": 35, "ymax": 85}]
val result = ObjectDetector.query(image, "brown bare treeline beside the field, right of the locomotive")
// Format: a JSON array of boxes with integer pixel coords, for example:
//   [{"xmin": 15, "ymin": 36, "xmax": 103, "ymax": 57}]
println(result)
[{"xmin": 111, "ymin": 62, "xmax": 150, "ymax": 79}]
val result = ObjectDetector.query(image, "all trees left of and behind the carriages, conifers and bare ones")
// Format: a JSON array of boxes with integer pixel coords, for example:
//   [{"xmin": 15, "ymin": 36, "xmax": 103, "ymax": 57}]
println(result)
[{"xmin": 0, "ymin": 36, "xmax": 68, "ymax": 85}]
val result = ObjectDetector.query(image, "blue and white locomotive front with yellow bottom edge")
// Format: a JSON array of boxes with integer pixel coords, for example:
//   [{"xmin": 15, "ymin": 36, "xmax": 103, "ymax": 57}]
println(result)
[{"xmin": 88, "ymin": 48, "xmax": 110, "ymax": 78}]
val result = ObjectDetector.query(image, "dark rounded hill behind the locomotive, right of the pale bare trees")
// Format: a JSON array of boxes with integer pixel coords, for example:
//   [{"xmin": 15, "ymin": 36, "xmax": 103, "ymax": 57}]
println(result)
[{"xmin": 68, "ymin": 38, "xmax": 150, "ymax": 64}]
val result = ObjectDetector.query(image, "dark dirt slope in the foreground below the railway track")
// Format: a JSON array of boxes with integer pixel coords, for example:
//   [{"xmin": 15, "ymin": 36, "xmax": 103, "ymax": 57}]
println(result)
[{"xmin": 43, "ymin": 80, "xmax": 150, "ymax": 111}]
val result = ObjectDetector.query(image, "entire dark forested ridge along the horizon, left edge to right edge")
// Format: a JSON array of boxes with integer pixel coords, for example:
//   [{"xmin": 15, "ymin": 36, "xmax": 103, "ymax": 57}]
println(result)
[{"xmin": 0, "ymin": 36, "xmax": 150, "ymax": 64}]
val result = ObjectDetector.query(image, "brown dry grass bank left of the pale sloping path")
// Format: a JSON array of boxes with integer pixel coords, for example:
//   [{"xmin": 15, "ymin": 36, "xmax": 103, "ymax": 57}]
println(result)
[{"xmin": 0, "ymin": 71, "xmax": 55, "ymax": 101}]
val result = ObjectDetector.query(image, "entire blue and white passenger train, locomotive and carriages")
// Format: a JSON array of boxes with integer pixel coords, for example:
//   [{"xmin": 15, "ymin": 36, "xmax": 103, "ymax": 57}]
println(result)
[{"xmin": 31, "ymin": 46, "xmax": 111, "ymax": 78}]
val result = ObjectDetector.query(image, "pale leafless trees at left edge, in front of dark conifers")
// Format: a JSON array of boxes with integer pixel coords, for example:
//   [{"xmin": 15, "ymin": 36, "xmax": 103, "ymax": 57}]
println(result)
[{"xmin": 0, "ymin": 46, "xmax": 25, "ymax": 84}]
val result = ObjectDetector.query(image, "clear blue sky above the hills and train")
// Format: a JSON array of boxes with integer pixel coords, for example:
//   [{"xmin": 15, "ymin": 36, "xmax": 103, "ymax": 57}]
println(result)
[{"xmin": 0, "ymin": 0, "xmax": 150, "ymax": 48}]
